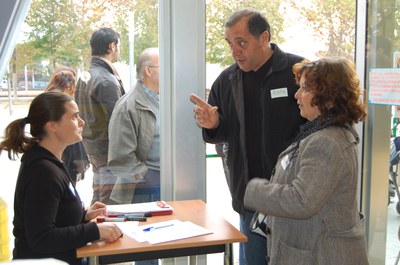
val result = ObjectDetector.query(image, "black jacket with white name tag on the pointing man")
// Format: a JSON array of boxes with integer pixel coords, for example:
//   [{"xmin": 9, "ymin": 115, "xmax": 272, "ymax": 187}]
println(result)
[{"xmin": 203, "ymin": 43, "xmax": 306, "ymax": 214}]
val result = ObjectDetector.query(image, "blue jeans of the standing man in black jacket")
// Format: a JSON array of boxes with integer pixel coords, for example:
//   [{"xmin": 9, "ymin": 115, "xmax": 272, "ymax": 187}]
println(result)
[{"xmin": 239, "ymin": 211, "xmax": 268, "ymax": 265}]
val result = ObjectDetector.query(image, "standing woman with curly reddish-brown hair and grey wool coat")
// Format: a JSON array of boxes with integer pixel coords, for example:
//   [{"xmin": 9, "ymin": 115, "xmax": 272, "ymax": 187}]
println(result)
[{"xmin": 245, "ymin": 58, "xmax": 368, "ymax": 265}]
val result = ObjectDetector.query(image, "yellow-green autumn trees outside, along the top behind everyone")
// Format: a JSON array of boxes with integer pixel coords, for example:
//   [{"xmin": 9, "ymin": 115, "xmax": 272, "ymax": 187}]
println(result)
[{"xmin": 10, "ymin": 0, "xmax": 362, "ymax": 90}]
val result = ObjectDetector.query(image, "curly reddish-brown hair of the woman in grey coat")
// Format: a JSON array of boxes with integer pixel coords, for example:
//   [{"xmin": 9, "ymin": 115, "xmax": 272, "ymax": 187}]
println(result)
[{"xmin": 293, "ymin": 57, "xmax": 367, "ymax": 126}]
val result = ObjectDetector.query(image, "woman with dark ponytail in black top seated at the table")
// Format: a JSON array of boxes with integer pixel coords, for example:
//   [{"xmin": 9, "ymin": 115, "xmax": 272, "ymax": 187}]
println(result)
[{"xmin": 0, "ymin": 92, "xmax": 122, "ymax": 265}]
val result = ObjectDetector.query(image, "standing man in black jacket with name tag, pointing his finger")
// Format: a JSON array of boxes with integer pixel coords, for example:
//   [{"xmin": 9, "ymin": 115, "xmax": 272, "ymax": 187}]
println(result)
[{"xmin": 191, "ymin": 10, "xmax": 305, "ymax": 265}]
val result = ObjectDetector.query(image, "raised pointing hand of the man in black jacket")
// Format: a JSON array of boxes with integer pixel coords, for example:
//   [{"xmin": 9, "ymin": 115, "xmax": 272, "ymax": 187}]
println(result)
[{"xmin": 190, "ymin": 94, "xmax": 219, "ymax": 129}]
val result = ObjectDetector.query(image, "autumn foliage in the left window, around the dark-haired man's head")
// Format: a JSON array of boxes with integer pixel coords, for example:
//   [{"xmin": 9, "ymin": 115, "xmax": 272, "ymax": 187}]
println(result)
[{"xmin": 15, "ymin": 0, "xmax": 158, "ymax": 71}]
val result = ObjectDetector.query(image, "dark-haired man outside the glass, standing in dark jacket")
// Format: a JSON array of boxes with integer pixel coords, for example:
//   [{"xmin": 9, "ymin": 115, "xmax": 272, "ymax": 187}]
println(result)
[{"xmin": 75, "ymin": 28, "xmax": 125, "ymax": 204}]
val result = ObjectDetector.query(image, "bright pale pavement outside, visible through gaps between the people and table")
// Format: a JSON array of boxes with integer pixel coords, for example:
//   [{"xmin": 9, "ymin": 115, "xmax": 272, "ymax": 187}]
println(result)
[{"xmin": 0, "ymin": 97, "xmax": 400, "ymax": 265}]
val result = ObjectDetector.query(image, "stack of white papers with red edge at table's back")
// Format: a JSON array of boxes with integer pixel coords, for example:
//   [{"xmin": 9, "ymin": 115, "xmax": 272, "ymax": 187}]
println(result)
[{"xmin": 107, "ymin": 201, "xmax": 174, "ymax": 215}]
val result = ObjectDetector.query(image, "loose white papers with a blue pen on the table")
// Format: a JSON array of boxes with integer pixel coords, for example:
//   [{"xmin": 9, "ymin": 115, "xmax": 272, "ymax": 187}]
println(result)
[{"xmin": 117, "ymin": 220, "xmax": 212, "ymax": 244}]
